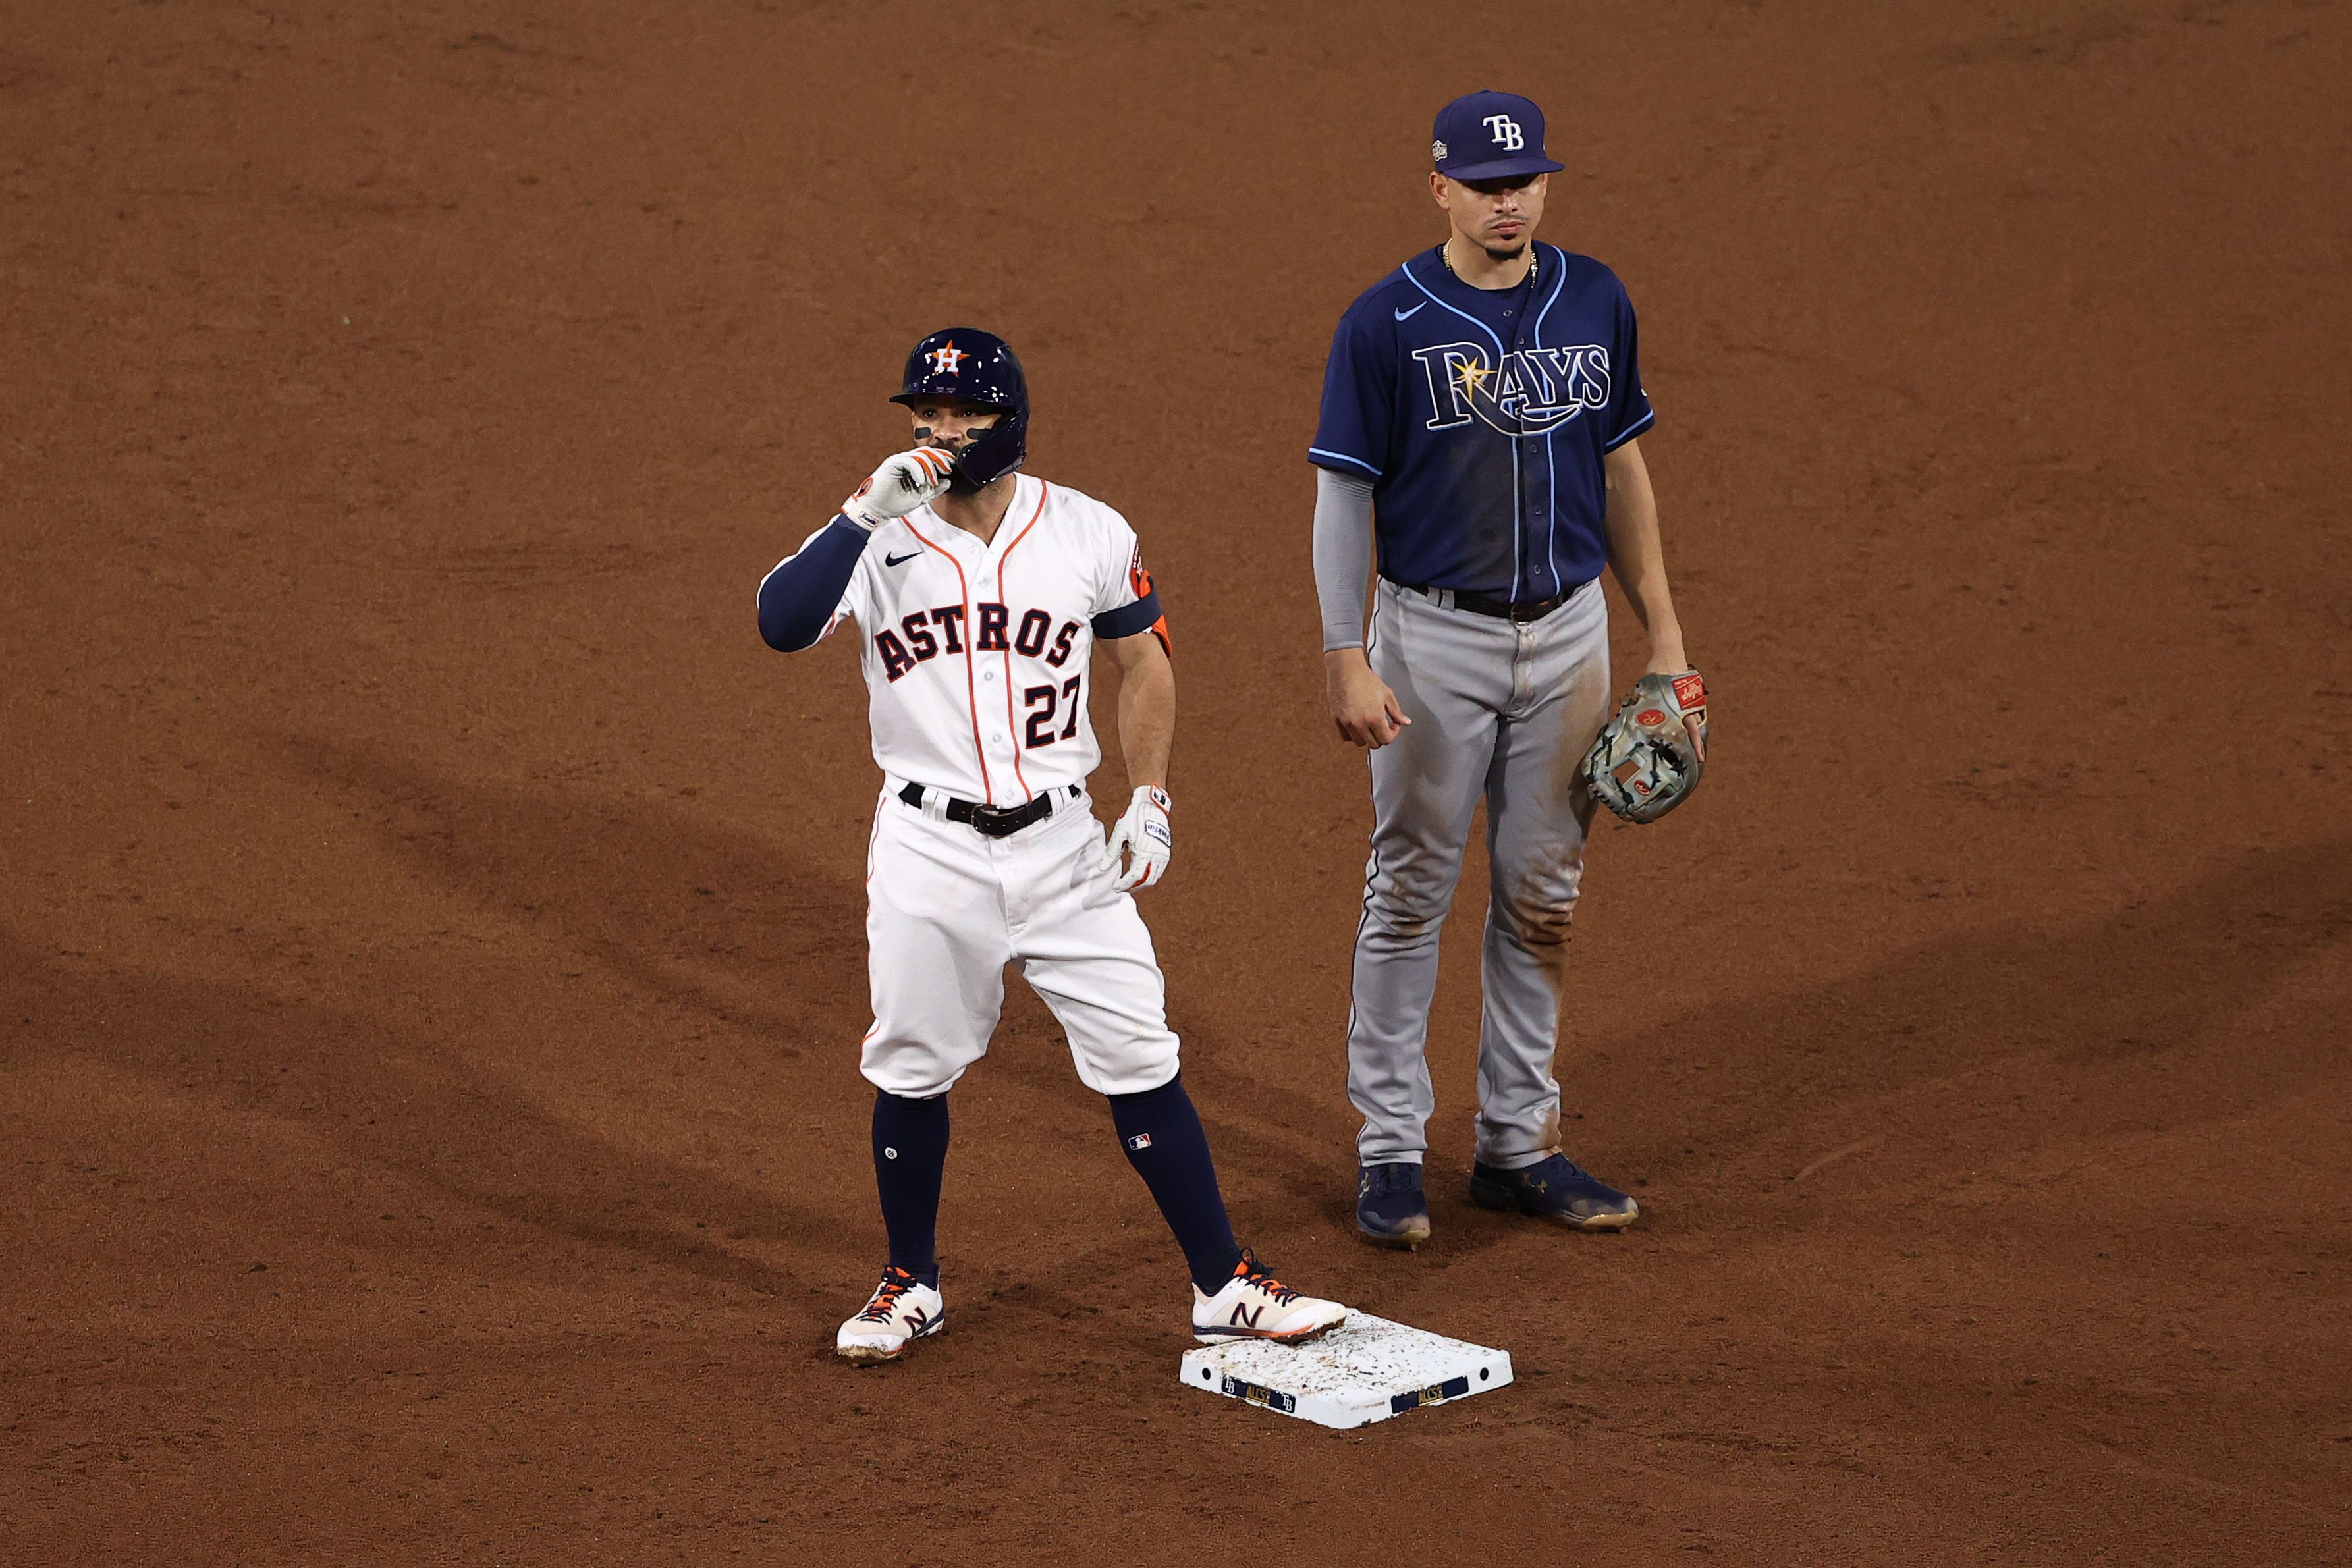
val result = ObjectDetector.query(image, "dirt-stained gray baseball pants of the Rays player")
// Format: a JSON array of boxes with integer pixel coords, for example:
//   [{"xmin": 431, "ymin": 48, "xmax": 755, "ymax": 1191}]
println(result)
[{"xmin": 1348, "ymin": 578, "xmax": 1609, "ymax": 1168}]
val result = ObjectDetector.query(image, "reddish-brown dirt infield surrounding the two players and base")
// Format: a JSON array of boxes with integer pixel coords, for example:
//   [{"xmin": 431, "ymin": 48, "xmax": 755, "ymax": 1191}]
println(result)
[{"xmin": 0, "ymin": 0, "xmax": 2352, "ymax": 1568}]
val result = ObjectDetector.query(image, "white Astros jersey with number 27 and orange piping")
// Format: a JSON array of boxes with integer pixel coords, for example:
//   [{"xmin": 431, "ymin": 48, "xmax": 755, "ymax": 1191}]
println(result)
[{"xmin": 802, "ymin": 475, "xmax": 1166, "ymax": 806}]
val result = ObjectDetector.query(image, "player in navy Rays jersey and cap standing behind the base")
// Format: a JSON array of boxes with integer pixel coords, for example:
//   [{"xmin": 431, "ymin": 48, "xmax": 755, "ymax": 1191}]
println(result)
[{"xmin": 1307, "ymin": 92, "xmax": 1703, "ymax": 1246}]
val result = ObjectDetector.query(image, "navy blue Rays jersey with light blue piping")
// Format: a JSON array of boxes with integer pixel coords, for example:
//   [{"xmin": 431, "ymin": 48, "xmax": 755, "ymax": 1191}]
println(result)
[{"xmin": 1307, "ymin": 244, "xmax": 1653, "ymax": 602}]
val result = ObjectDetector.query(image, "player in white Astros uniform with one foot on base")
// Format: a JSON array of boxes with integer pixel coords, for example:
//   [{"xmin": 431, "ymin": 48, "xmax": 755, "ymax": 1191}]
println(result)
[{"xmin": 759, "ymin": 327, "xmax": 1348, "ymax": 1361}]
